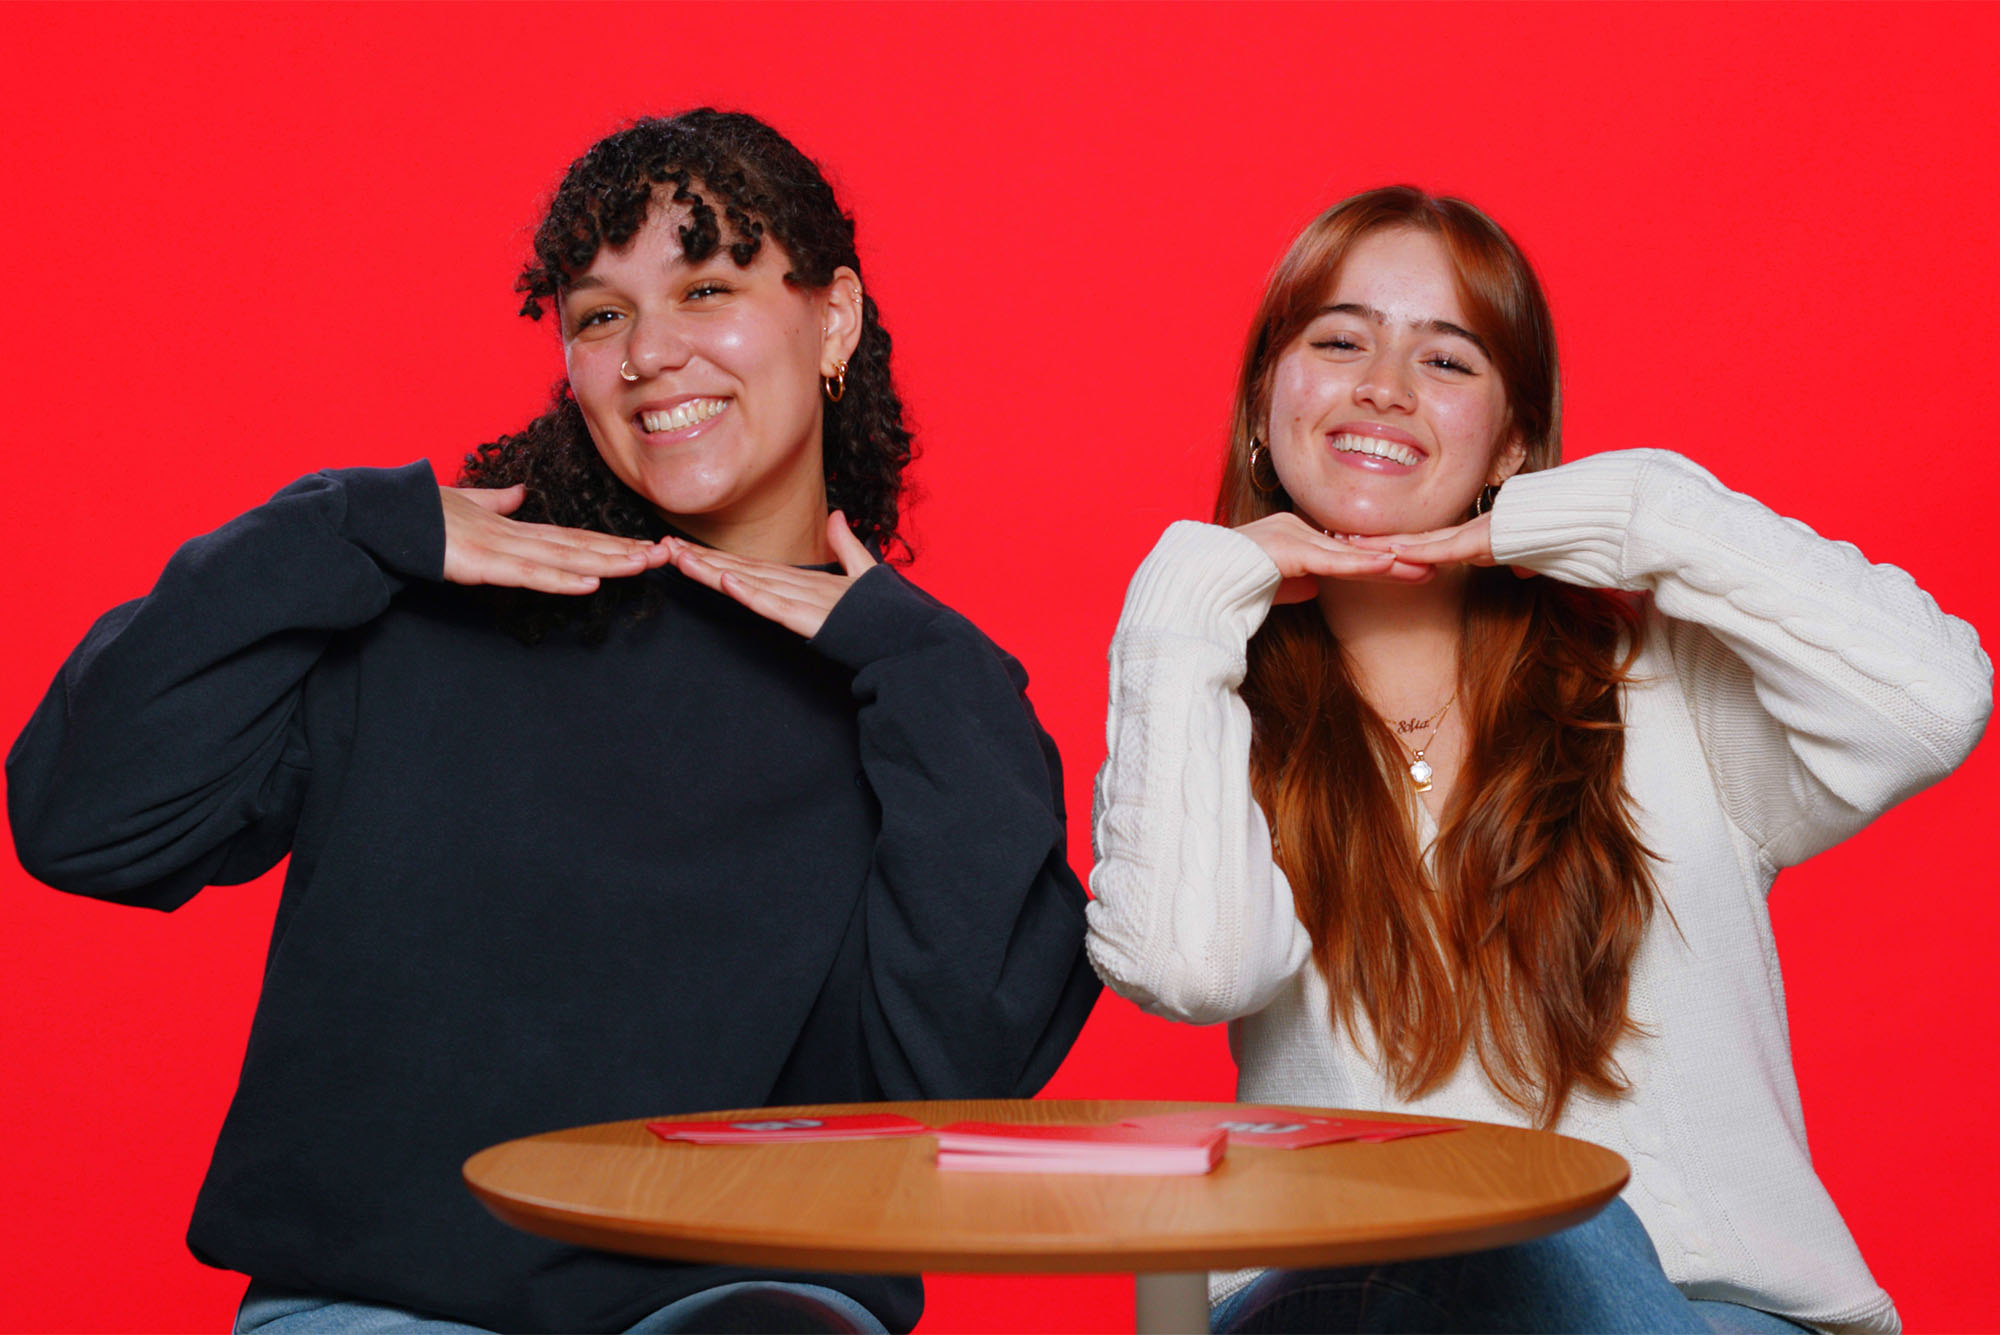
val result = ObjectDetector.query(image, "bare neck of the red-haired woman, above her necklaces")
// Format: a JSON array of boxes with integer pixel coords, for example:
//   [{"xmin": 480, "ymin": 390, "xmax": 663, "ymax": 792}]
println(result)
[{"xmin": 1320, "ymin": 566, "xmax": 1470, "ymax": 717}]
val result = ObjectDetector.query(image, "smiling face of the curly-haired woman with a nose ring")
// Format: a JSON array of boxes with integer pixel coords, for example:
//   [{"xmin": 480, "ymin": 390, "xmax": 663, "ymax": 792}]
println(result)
[{"xmin": 560, "ymin": 208, "xmax": 860, "ymax": 562}]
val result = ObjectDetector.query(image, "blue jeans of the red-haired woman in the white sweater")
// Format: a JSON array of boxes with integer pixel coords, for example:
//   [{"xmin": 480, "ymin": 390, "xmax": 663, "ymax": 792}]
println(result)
[{"xmin": 1208, "ymin": 1201, "xmax": 1808, "ymax": 1335}]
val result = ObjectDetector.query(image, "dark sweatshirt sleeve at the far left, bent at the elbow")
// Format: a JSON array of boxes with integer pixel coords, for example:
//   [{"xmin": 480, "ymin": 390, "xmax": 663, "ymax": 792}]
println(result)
[{"xmin": 8, "ymin": 462, "xmax": 444, "ymax": 909}]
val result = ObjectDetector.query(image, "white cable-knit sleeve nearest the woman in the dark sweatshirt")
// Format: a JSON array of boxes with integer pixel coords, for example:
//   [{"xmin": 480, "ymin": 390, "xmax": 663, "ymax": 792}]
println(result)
[{"xmin": 1090, "ymin": 522, "xmax": 1310, "ymax": 1023}]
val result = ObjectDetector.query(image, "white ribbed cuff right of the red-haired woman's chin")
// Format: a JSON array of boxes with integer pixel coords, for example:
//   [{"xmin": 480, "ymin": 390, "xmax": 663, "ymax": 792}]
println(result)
[{"xmin": 1492, "ymin": 450, "xmax": 1660, "ymax": 590}]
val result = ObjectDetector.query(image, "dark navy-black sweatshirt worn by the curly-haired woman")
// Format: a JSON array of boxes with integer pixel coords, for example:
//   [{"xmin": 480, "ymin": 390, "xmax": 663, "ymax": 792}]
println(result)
[{"xmin": 8, "ymin": 464, "xmax": 1098, "ymax": 1331}]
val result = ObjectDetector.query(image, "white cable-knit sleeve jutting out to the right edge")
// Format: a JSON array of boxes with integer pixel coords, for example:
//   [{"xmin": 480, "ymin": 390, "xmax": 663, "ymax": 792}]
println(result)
[{"xmin": 1492, "ymin": 450, "xmax": 1992, "ymax": 867}]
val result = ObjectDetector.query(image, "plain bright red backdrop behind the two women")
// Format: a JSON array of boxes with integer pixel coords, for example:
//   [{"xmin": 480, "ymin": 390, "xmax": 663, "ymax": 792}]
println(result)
[{"xmin": 0, "ymin": 4, "xmax": 2000, "ymax": 1331}]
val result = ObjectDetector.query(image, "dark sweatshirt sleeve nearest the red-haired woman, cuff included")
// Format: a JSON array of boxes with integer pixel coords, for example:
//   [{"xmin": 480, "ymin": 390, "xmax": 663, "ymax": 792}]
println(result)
[{"xmin": 812, "ymin": 566, "xmax": 1098, "ymax": 1099}]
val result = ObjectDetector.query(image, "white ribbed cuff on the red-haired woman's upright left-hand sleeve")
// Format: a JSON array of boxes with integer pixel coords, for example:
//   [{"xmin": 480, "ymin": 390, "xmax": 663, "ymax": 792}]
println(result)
[{"xmin": 1118, "ymin": 520, "xmax": 1278, "ymax": 648}]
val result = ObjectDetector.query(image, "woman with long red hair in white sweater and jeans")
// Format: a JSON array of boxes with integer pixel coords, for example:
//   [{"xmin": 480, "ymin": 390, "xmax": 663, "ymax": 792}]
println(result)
[{"xmin": 1090, "ymin": 188, "xmax": 1992, "ymax": 1331}]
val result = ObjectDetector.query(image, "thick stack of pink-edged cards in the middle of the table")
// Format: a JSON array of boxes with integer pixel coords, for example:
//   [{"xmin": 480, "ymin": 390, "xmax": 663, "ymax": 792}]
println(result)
[{"xmin": 938, "ymin": 1121, "xmax": 1228, "ymax": 1175}]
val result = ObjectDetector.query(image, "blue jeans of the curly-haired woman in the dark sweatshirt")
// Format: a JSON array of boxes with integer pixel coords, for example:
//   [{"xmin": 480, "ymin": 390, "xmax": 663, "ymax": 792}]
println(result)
[{"xmin": 236, "ymin": 1279, "xmax": 888, "ymax": 1335}]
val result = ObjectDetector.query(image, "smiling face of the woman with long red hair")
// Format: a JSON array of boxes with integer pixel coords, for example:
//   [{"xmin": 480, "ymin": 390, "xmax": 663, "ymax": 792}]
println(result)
[{"xmin": 1266, "ymin": 228, "xmax": 1522, "ymax": 534}]
